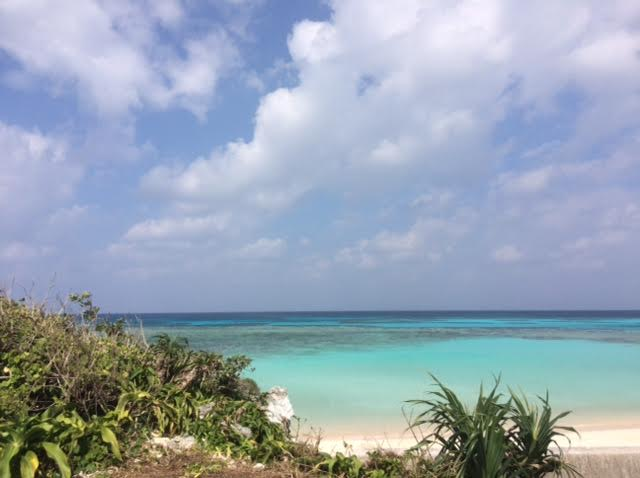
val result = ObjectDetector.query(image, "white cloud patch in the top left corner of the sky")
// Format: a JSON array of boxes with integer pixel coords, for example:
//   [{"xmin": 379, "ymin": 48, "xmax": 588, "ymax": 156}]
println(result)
[{"xmin": 0, "ymin": 0, "xmax": 237, "ymax": 117}]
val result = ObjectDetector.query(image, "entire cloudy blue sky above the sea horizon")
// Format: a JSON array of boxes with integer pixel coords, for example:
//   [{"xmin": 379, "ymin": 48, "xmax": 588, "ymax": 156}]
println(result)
[{"xmin": 0, "ymin": 0, "xmax": 640, "ymax": 312}]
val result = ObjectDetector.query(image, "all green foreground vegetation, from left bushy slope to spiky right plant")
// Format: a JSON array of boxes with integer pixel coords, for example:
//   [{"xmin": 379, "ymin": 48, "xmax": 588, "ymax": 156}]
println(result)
[{"xmin": 0, "ymin": 293, "xmax": 577, "ymax": 478}]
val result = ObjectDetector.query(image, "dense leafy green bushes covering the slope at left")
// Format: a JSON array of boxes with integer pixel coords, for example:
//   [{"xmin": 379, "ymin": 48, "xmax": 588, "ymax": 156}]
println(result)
[{"xmin": 0, "ymin": 294, "xmax": 278, "ymax": 478}]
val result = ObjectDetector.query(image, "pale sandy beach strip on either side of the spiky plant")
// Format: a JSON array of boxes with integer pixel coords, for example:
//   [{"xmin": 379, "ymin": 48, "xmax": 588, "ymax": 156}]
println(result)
[{"xmin": 320, "ymin": 424, "xmax": 640, "ymax": 456}]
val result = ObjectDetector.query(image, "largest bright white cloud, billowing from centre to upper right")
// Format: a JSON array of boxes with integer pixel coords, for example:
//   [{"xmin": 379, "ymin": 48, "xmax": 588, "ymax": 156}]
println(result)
[{"xmin": 142, "ymin": 0, "xmax": 640, "ymax": 224}]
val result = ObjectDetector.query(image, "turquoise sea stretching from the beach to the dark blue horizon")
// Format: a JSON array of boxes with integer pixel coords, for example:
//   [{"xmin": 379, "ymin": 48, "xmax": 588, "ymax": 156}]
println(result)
[{"xmin": 119, "ymin": 311, "xmax": 640, "ymax": 436}]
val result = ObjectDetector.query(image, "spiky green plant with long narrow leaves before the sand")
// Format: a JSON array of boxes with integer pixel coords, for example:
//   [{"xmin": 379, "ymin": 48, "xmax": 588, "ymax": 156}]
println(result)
[{"xmin": 410, "ymin": 379, "xmax": 579, "ymax": 478}]
